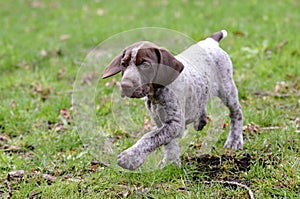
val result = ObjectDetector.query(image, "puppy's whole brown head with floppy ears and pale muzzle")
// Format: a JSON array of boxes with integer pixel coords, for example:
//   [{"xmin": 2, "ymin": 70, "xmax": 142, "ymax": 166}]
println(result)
[{"xmin": 102, "ymin": 41, "xmax": 184, "ymax": 98}]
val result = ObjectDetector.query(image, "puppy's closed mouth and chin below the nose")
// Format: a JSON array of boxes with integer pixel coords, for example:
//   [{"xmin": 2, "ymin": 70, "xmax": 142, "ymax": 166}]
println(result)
[{"xmin": 120, "ymin": 84, "xmax": 150, "ymax": 98}]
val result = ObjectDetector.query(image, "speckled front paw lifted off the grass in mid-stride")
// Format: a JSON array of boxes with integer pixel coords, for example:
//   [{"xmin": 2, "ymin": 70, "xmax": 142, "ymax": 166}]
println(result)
[{"xmin": 117, "ymin": 148, "xmax": 148, "ymax": 170}]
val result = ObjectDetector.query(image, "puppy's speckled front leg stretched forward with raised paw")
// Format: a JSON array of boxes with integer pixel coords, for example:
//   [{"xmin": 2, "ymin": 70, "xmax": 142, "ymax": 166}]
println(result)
[{"xmin": 117, "ymin": 89, "xmax": 184, "ymax": 170}]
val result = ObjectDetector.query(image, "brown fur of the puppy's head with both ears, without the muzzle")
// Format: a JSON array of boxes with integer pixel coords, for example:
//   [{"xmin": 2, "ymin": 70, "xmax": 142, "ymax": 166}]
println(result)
[{"xmin": 102, "ymin": 41, "xmax": 184, "ymax": 86}]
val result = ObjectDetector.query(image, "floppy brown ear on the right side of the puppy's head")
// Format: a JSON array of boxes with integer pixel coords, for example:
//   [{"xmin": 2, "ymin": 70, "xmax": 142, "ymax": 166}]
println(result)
[{"xmin": 154, "ymin": 48, "xmax": 184, "ymax": 86}]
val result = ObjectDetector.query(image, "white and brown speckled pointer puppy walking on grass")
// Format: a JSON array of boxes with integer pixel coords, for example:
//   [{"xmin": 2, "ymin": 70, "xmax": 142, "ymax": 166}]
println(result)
[{"xmin": 102, "ymin": 30, "xmax": 243, "ymax": 170}]
